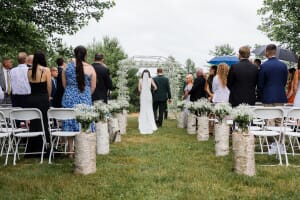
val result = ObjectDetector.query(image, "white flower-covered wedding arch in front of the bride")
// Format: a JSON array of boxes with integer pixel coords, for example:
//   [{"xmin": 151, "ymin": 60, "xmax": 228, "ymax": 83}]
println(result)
[{"xmin": 117, "ymin": 56, "xmax": 183, "ymax": 116}]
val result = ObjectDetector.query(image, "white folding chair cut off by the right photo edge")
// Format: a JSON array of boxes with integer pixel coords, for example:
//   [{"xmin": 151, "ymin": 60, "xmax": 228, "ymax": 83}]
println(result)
[{"xmin": 283, "ymin": 107, "xmax": 300, "ymax": 165}]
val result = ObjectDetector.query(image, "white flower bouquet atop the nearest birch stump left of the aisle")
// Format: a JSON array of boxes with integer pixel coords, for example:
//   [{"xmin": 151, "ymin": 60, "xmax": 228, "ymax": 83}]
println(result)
[{"xmin": 75, "ymin": 104, "xmax": 98, "ymax": 132}]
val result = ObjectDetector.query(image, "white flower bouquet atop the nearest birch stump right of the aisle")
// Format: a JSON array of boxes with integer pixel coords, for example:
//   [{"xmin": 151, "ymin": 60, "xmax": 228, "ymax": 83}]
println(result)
[{"xmin": 232, "ymin": 104, "xmax": 254, "ymax": 132}]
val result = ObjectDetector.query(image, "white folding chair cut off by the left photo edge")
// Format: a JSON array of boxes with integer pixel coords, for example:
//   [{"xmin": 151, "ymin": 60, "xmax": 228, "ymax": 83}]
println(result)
[{"xmin": 0, "ymin": 111, "xmax": 12, "ymax": 165}]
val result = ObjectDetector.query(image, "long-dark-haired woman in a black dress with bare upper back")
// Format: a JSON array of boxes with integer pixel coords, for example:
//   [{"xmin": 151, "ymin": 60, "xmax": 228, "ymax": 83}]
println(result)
[{"xmin": 25, "ymin": 52, "xmax": 51, "ymax": 155}]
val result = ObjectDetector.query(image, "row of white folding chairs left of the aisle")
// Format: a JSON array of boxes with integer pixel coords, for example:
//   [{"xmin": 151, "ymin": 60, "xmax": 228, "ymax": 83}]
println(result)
[{"xmin": 0, "ymin": 107, "xmax": 79, "ymax": 165}]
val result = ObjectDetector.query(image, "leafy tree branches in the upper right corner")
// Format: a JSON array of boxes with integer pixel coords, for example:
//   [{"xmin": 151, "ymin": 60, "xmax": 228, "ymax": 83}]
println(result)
[{"xmin": 257, "ymin": 0, "xmax": 300, "ymax": 53}]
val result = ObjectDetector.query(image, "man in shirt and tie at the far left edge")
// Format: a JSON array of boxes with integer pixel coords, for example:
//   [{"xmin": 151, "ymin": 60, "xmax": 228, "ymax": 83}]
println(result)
[{"xmin": 0, "ymin": 58, "xmax": 13, "ymax": 104}]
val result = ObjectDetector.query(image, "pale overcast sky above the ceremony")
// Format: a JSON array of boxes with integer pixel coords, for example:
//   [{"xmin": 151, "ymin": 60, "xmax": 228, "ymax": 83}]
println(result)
[{"xmin": 63, "ymin": 0, "xmax": 271, "ymax": 67}]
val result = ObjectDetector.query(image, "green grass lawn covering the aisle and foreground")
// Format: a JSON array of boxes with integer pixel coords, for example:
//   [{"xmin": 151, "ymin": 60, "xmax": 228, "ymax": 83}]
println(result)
[{"xmin": 0, "ymin": 117, "xmax": 300, "ymax": 200}]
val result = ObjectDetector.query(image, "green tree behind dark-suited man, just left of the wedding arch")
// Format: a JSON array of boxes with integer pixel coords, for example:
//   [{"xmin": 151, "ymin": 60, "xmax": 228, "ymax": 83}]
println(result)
[{"xmin": 87, "ymin": 36, "xmax": 127, "ymax": 97}]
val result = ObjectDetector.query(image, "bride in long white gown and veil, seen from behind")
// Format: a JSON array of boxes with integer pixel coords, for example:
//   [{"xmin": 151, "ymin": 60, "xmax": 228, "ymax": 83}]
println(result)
[{"xmin": 138, "ymin": 69, "xmax": 157, "ymax": 134}]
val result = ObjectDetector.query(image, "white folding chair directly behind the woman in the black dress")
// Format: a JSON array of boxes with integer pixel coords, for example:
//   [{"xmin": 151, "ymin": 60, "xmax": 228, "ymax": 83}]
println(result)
[{"xmin": 10, "ymin": 108, "xmax": 46, "ymax": 165}]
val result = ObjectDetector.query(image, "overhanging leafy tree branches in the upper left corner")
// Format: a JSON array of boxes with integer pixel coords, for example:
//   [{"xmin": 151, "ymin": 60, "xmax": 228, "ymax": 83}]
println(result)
[{"xmin": 0, "ymin": 0, "xmax": 115, "ymax": 58}]
